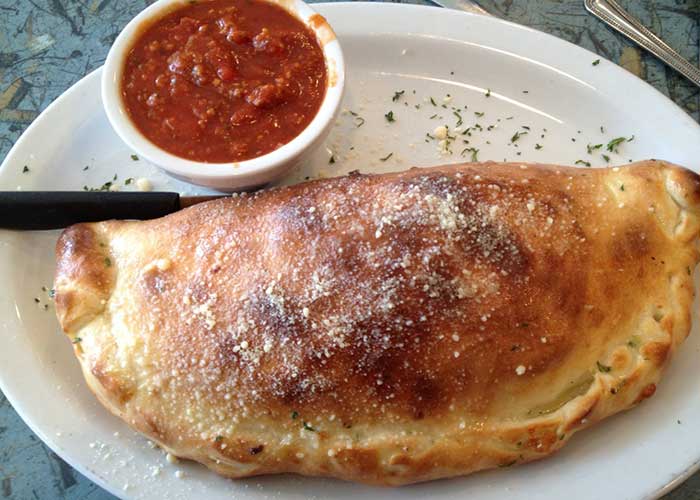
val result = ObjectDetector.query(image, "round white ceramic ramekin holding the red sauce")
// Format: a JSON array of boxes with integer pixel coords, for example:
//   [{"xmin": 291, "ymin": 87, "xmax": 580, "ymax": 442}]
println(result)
[{"xmin": 102, "ymin": 0, "xmax": 345, "ymax": 191}]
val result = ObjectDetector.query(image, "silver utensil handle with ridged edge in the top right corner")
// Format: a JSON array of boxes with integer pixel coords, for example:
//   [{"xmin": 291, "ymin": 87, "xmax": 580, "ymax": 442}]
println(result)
[{"xmin": 584, "ymin": 0, "xmax": 700, "ymax": 87}]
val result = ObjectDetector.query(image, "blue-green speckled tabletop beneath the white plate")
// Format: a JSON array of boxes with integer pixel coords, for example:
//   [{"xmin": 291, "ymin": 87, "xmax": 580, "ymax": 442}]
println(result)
[{"xmin": 0, "ymin": 0, "xmax": 700, "ymax": 500}]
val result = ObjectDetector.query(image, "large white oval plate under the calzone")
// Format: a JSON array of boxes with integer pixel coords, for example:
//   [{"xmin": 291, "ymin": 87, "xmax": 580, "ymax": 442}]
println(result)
[{"xmin": 0, "ymin": 3, "xmax": 700, "ymax": 500}]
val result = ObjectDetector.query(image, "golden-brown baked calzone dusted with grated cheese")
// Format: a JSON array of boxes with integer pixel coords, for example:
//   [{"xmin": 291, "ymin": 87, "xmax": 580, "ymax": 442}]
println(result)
[{"xmin": 55, "ymin": 161, "xmax": 700, "ymax": 485}]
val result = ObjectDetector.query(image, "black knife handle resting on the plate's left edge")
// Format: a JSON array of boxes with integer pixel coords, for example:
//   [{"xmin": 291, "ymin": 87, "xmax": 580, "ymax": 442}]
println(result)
[{"xmin": 0, "ymin": 191, "xmax": 180, "ymax": 229}]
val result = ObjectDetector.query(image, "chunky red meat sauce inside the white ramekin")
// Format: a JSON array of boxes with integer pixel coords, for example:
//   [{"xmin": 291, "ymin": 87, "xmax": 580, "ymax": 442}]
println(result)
[{"xmin": 122, "ymin": 0, "xmax": 327, "ymax": 163}]
